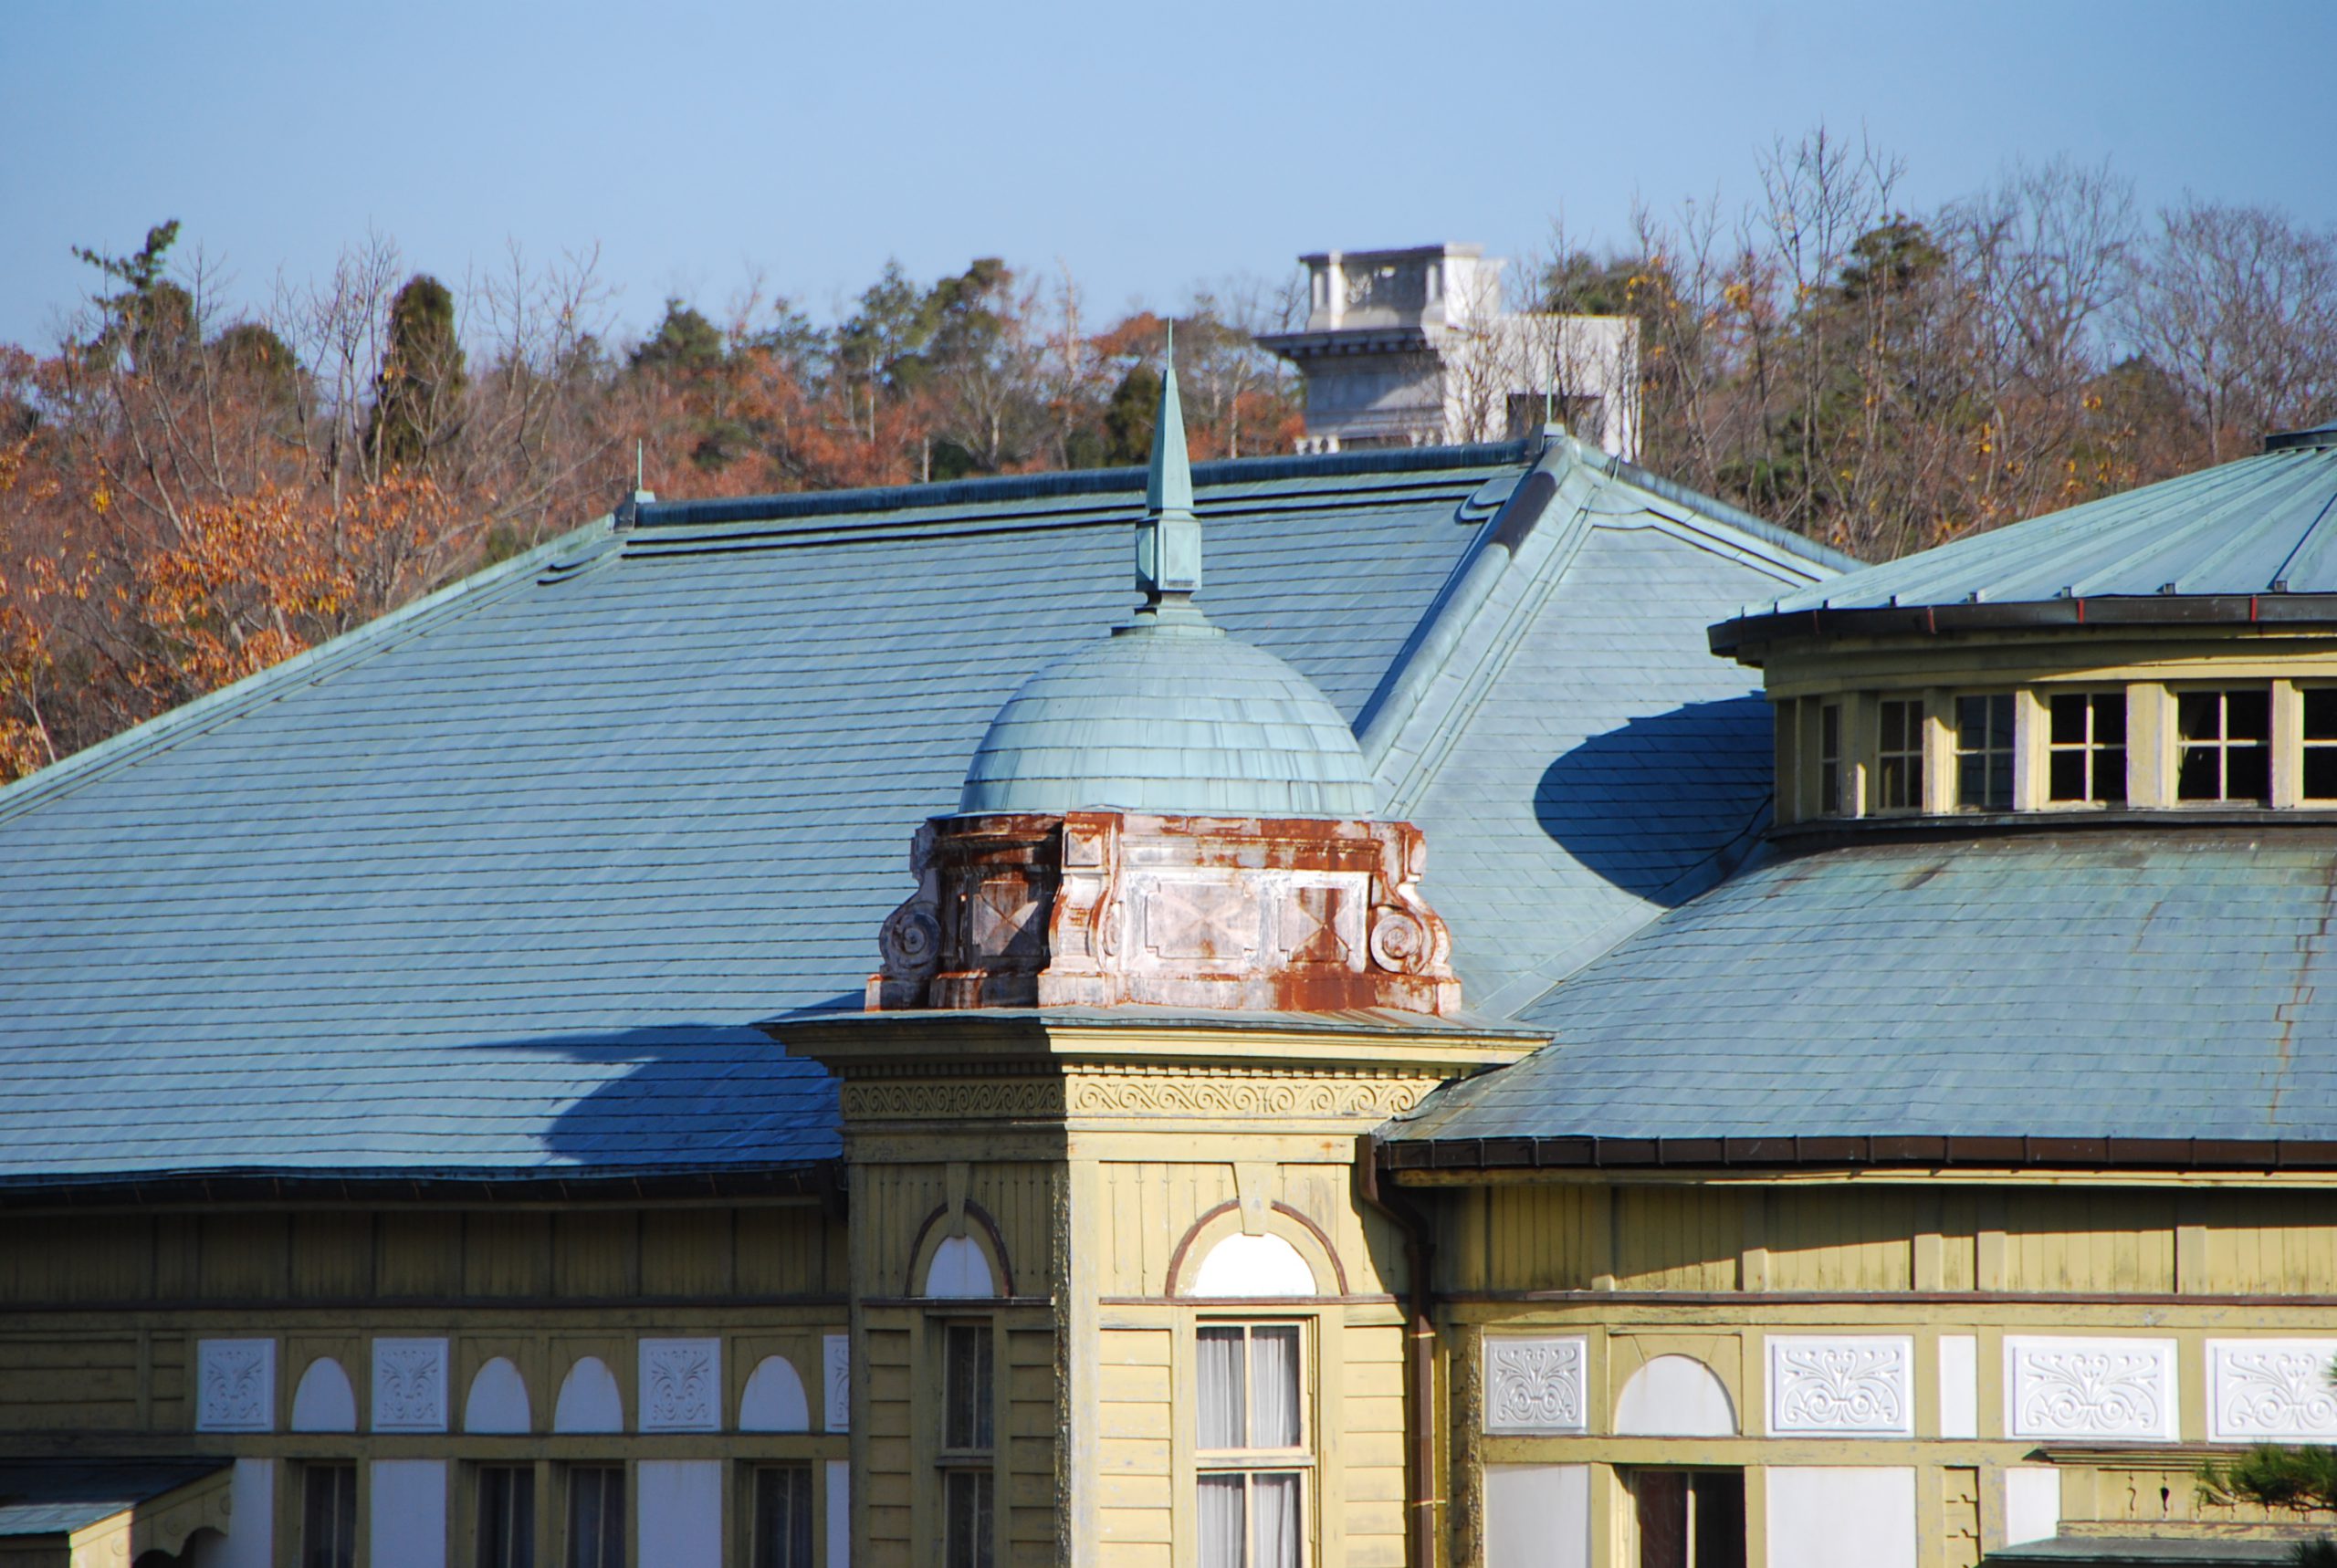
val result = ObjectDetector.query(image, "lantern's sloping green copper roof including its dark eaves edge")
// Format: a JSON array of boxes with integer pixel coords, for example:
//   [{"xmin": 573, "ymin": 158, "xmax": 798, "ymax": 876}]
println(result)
[{"xmin": 1713, "ymin": 430, "xmax": 2337, "ymax": 647}]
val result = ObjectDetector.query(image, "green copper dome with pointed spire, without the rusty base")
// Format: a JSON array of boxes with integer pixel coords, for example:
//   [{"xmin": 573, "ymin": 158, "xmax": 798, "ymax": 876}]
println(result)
[{"xmin": 959, "ymin": 331, "xmax": 1378, "ymax": 818}]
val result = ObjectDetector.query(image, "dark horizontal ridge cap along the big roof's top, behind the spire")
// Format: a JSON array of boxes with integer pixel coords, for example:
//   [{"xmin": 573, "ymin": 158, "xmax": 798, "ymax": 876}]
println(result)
[{"xmin": 635, "ymin": 437, "xmax": 1533, "ymax": 528}]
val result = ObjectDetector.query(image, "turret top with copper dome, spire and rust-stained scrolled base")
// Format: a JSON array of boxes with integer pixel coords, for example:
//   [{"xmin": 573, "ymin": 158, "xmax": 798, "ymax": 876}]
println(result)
[{"xmin": 867, "ymin": 336, "xmax": 1461, "ymax": 1014}]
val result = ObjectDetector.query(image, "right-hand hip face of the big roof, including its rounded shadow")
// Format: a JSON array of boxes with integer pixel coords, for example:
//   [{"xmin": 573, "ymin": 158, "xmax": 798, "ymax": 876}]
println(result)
[{"xmin": 1357, "ymin": 439, "xmax": 1846, "ymax": 1017}]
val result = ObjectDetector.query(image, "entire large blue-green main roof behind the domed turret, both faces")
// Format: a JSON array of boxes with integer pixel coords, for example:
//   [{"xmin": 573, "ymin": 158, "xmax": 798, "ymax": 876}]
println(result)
[{"xmin": 0, "ymin": 442, "xmax": 1832, "ymax": 1185}]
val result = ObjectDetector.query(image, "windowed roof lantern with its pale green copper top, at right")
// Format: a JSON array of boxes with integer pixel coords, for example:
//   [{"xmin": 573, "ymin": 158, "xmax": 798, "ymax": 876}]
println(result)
[{"xmin": 1711, "ymin": 425, "xmax": 2337, "ymax": 831}]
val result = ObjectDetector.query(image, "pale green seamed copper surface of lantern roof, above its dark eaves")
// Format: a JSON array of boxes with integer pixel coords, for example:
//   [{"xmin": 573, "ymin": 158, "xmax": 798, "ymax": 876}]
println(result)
[{"xmin": 1748, "ymin": 433, "xmax": 2337, "ymax": 614}]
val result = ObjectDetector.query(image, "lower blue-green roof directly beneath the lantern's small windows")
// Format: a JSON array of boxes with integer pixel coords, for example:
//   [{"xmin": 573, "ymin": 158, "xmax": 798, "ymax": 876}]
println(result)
[{"xmin": 1395, "ymin": 825, "xmax": 2337, "ymax": 1140}]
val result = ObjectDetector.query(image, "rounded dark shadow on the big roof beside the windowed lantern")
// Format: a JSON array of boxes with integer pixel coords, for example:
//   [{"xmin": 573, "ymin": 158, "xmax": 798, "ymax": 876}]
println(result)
[{"xmin": 1533, "ymin": 694, "xmax": 1771, "ymax": 906}]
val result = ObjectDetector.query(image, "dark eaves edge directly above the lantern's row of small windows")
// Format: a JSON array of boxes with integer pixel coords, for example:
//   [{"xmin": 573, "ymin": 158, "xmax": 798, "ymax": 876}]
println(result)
[{"xmin": 1706, "ymin": 593, "xmax": 2337, "ymax": 664}]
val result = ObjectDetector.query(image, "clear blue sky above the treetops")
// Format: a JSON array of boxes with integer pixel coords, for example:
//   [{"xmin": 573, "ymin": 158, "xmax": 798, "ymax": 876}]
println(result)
[{"xmin": 0, "ymin": 0, "xmax": 2337, "ymax": 346}]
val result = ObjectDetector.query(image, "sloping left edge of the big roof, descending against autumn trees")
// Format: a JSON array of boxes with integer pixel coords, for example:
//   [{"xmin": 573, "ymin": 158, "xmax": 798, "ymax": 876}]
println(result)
[{"xmin": 0, "ymin": 514, "xmax": 614, "ymax": 822}]
